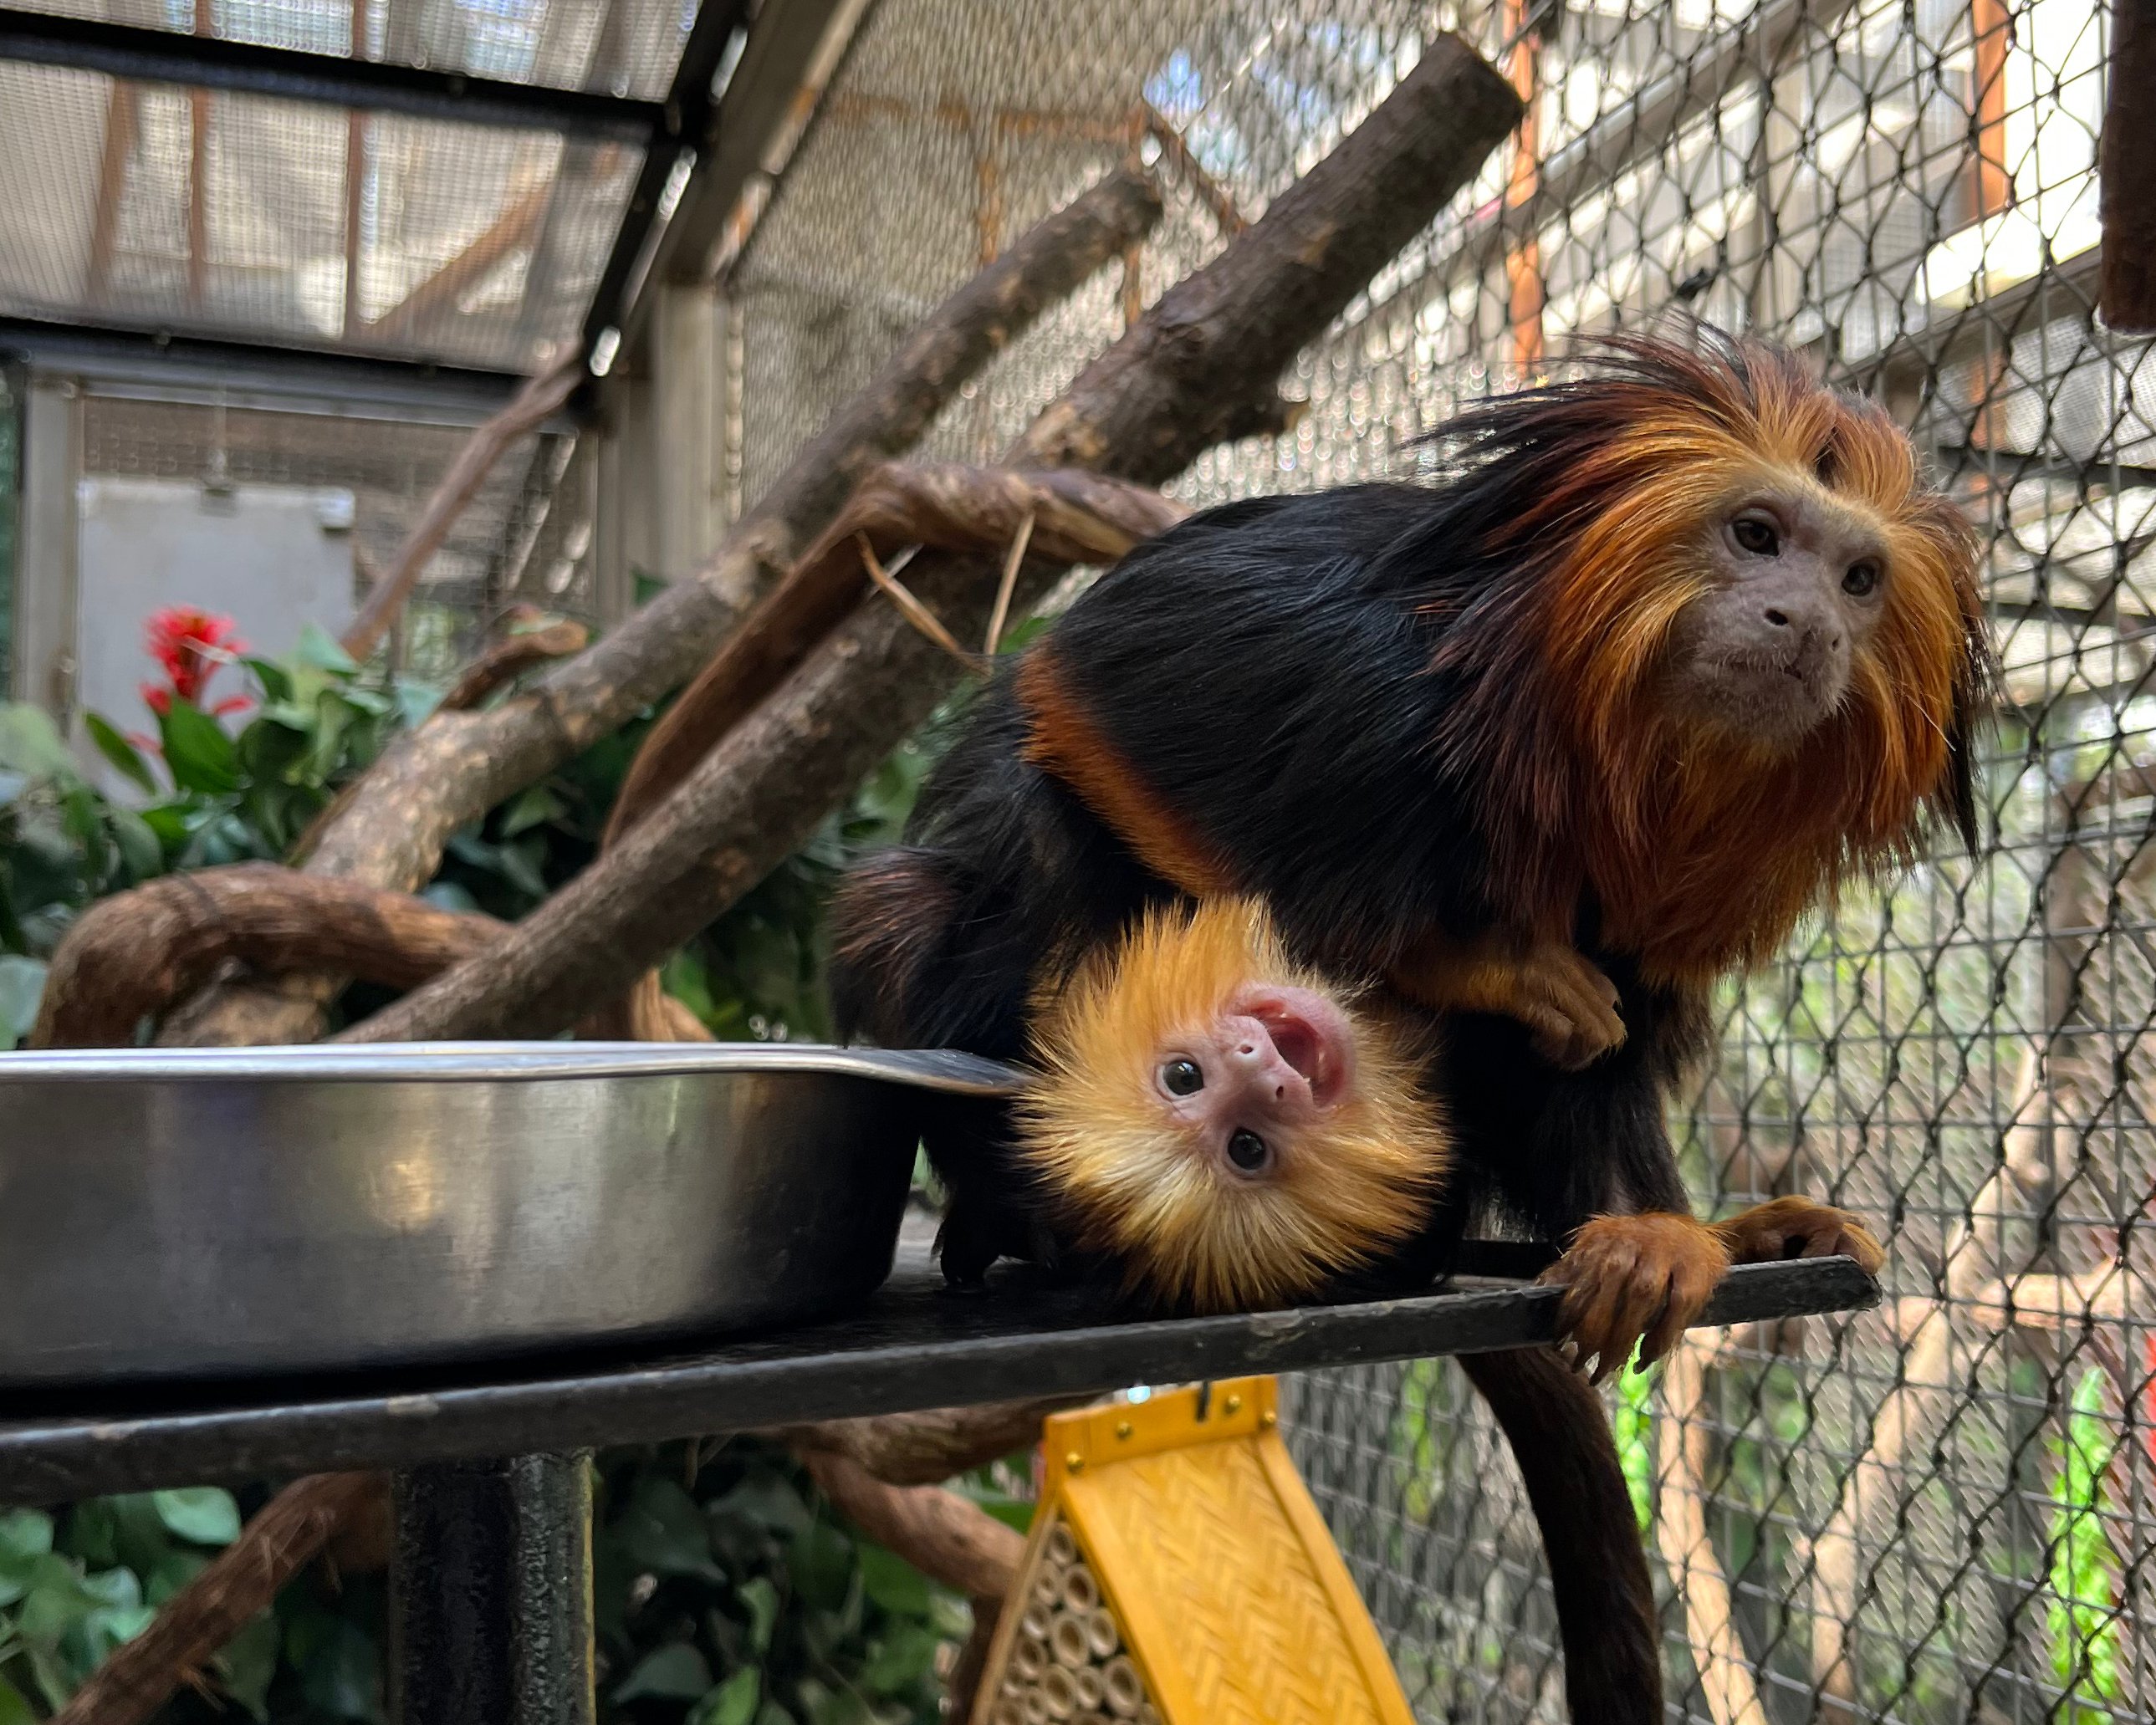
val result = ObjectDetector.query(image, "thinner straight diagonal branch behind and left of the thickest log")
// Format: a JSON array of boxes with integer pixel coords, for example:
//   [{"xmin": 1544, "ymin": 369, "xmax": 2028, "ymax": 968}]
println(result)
[{"xmin": 166, "ymin": 175, "xmax": 1160, "ymax": 1044}]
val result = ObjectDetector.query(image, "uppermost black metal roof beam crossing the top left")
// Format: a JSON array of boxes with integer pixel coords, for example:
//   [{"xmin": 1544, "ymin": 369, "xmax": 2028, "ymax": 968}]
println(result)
[{"xmin": 0, "ymin": 4, "xmax": 664, "ymax": 146}]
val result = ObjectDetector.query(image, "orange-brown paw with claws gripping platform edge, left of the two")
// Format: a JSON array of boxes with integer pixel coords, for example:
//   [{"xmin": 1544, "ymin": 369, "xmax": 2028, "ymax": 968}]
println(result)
[{"xmin": 1541, "ymin": 1210, "xmax": 1729, "ymax": 1385}]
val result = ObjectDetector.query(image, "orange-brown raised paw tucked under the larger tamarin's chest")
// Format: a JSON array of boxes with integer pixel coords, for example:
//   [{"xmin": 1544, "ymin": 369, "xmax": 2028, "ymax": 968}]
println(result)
[{"xmin": 1391, "ymin": 929, "xmax": 1626, "ymax": 1072}]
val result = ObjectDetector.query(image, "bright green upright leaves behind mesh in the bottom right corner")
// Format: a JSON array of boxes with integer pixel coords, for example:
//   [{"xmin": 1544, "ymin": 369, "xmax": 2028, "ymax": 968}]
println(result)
[{"xmin": 2044, "ymin": 1367, "xmax": 2123, "ymax": 1725}]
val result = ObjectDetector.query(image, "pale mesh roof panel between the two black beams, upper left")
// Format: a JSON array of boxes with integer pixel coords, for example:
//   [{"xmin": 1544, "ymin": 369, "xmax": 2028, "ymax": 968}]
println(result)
[{"xmin": 0, "ymin": 43, "xmax": 642, "ymax": 371}]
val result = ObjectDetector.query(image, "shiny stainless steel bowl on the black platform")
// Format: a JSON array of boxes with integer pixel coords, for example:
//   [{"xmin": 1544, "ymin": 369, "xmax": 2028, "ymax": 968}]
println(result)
[{"xmin": 0, "ymin": 1042, "xmax": 1014, "ymax": 1386}]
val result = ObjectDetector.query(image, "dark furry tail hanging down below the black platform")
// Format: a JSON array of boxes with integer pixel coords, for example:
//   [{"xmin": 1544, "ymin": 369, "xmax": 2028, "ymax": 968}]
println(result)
[{"xmin": 1459, "ymin": 1348, "xmax": 1663, "ymax": 1725}]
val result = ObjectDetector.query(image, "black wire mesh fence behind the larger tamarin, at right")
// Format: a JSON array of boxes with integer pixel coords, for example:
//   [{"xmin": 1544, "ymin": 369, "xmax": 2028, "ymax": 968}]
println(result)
[{"xmin": 728, "ymin": 0, "xmax": 2156, "ymax": 1725}]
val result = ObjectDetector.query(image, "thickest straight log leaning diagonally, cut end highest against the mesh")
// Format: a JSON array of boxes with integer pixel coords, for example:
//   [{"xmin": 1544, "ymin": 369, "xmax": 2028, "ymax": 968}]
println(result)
[{"xmin": 345, "ymin": 37, "xmax": 1520, "ymax": 1042}]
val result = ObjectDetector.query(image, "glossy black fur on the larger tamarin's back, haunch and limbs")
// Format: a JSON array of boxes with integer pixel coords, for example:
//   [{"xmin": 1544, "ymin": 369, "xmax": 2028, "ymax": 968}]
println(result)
[{"xmin": 832, "ymin": 485, "xmax": 1704, "ymax": 1283}]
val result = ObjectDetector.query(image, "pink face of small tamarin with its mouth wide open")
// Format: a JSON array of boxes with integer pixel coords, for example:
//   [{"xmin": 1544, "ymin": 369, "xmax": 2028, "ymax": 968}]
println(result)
[{"xmin": 1153, "ymin": 983, "xmax": 1354, "ymax": 1180}]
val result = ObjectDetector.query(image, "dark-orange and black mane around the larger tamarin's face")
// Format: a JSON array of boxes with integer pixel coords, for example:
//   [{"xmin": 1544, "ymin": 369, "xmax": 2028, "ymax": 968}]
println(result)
[{"xmin": 1440, "ymin": 340, "xmax": 1985, "ymax": 985}]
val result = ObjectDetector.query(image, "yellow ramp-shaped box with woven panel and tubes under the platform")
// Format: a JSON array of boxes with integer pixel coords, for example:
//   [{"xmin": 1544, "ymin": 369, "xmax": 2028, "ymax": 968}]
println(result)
[{"xmin": 973, "ymin": 1378, "xmax": 1414, "ymax": 1725}]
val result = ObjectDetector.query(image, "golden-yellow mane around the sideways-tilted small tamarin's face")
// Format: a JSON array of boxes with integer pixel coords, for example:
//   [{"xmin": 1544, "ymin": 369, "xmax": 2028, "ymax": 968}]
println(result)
[{"xmin": 1018, "ymin": 899, "xmax": 1451, "ymax": 1311}]
